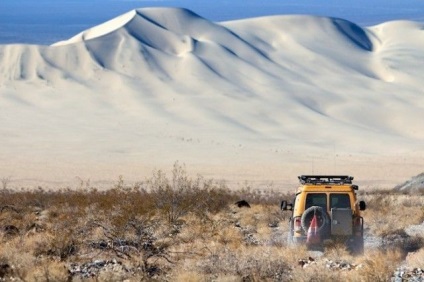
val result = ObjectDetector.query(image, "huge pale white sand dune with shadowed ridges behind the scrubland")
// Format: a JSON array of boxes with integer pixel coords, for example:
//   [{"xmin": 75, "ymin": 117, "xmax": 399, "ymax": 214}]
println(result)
[{"xmin": 0, "ymin": 8, "xmax": 424, "ymax": 189}]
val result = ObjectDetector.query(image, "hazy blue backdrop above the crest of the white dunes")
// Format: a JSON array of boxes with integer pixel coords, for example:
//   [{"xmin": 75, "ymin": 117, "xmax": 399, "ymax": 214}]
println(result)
[{"xmin": 0, "ymin": 0, "xmax": 424, "ymax": 45}]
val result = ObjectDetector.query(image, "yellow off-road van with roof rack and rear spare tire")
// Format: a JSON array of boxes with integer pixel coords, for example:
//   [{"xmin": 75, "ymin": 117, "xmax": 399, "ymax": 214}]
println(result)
[{"xmin": 281, "ymin": 175, "xmax": 366, "ymax": 254}]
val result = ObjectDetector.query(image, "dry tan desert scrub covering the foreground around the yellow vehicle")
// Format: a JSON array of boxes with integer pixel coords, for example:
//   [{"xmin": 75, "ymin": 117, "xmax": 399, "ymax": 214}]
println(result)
[{"xmin": 0, "ymin": 164, "xmax": 424, "ymax": 281}]
